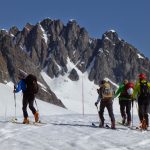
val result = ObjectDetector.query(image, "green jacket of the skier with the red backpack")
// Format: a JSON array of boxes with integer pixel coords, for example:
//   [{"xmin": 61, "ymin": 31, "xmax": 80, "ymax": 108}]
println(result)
[{"xmin": 114, "ymin": 83, "xmax": 129, "ymax": 100}]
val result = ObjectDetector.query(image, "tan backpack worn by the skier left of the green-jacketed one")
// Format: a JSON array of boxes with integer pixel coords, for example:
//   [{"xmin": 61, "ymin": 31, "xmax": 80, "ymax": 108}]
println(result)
[{"xmin": 101, "ymin": 82, "xmax": 113, "ymax": 99}]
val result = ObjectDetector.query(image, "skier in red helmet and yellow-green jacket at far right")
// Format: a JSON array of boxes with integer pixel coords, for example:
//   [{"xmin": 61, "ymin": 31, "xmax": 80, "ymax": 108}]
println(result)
[{"xmin": 133, "ymin": 73, "xmax": 150, "ymax": 129}]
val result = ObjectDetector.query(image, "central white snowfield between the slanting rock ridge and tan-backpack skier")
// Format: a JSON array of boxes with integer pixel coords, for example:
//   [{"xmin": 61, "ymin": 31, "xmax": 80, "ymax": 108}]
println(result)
[{"xmin": 42, "ymin": 72, "xmax": 98, "ymax": 114}]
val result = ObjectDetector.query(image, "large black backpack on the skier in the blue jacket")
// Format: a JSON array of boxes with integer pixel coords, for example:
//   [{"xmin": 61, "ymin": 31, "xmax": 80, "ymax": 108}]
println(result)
[{"xmin": 25, "ymin": 74, "xmax": 39, "ymax": 94}]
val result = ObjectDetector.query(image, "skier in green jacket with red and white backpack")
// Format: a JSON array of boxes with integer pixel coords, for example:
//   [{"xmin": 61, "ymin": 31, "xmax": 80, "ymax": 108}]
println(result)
[{"xmin": 114, "ymin": 79, "xmax": 134, "ymax": 126}]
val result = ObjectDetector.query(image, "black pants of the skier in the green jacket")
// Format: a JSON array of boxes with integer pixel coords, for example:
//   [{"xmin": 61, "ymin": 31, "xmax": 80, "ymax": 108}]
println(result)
[{"xmin": 119, "ymin": 100, "xmax": 131, "ymax": 122}]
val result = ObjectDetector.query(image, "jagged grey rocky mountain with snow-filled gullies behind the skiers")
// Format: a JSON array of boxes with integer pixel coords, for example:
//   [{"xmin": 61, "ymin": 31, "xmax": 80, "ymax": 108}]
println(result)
[{"xmin": 0, "ymin": 18, "xmax": 150, "ymax": 108}]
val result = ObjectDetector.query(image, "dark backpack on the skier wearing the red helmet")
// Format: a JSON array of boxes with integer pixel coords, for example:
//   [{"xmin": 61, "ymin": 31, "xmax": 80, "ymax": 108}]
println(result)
[{"xmin": 140, "ymin": 81, "xmax": 150, "ymax": 98}]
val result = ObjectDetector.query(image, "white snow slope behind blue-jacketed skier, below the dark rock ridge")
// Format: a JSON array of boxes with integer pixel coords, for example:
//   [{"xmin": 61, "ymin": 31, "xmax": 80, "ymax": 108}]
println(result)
[{"xmin": 0, "ymin": 82, "xmax": 73, "ymax": 119}]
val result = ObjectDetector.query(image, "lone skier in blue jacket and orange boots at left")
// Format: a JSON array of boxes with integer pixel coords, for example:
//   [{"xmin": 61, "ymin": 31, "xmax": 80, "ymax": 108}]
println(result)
[{"xmin": 14, "ymin": 74, "xmax": 39, "ymax": 124}]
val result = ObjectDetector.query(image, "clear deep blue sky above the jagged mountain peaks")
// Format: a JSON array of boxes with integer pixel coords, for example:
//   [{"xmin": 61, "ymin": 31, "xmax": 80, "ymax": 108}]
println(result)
[{"xmin": 0, "ymin": 0, "xmax": 150, "ymax": 58}]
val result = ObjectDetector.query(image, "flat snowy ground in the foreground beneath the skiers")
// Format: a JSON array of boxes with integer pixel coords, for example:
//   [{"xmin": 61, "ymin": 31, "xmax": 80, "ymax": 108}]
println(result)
[{"xmin": 0, "ymin": 114, "xmax": 150, "ymax": 150}]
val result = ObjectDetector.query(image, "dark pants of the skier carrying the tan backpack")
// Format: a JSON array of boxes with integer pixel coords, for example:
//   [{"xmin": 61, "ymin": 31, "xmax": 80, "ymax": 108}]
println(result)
[{"xmin": 99, "ymin": 100, "xmax": 115, "ymax": 122}]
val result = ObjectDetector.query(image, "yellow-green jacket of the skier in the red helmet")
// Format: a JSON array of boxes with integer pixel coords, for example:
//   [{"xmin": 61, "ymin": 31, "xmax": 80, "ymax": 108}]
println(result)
[{"xmin": 133, "ymin": 79, "xmax": 150, "ymax": 99}]
